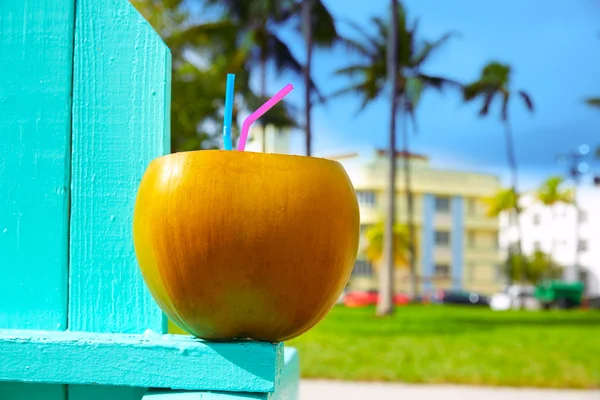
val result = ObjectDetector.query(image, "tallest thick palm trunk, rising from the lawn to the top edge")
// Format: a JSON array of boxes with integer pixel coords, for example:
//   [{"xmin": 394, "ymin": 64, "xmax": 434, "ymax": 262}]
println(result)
[{"xmin": 377, "ymin": 0, "xmax": 398, "ymax": 316}]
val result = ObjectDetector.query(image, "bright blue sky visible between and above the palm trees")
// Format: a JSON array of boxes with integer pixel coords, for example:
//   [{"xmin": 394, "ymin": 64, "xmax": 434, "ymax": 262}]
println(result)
[{"xmin": 254, "ymin": 0, "xmax": 600, "ymax": 189}]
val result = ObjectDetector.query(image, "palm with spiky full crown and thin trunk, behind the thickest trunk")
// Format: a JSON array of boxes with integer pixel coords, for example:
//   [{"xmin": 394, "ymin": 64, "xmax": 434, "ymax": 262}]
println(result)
[{"xmin": 333, "ymin": 1, "xmax": 459, "ymax": 311}]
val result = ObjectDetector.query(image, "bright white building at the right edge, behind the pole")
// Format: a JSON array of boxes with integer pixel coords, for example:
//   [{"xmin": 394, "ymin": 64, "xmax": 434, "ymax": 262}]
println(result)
[{"xmin": 499, "ymin": 187, "xmax": 600, "ymax": 296}]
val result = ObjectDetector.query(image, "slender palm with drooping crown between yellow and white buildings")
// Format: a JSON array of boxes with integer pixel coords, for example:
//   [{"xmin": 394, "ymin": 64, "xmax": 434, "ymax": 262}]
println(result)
[{"xmin": 463, "ymin": 61, "xmax": 533, "ymax": 268}]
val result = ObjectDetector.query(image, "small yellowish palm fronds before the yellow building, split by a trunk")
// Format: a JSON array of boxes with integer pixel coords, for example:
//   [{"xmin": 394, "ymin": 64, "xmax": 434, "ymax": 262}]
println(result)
[{"xmin": 362, "ymin": 221, "xmax": 409, "ymax": 267}]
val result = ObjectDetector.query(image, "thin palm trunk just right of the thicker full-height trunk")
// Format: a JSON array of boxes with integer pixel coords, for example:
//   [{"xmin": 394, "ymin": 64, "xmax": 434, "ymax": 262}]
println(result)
[{"xmin": 400, "ymin": 103, "xmax": 418, "ymax": 299}]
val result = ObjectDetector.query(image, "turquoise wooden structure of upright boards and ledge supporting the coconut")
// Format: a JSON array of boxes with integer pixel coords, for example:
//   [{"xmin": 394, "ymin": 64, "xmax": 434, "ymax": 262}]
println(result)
[{"xmin": 0, "ymin": 0, "xmax": 298, "ymax": 400}]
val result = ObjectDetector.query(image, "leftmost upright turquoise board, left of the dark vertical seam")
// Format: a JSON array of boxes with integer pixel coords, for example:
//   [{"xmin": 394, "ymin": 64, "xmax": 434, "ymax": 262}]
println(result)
[{"xmin": 0, "ymin": 0, "xmax": 74, "ymax": 329}]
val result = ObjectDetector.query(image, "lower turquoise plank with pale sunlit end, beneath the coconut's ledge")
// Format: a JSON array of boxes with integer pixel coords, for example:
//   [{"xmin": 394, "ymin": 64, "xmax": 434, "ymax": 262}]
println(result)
[{"xmin": 143, "ymin": 347, "xmax": 300, "ymax": 400}]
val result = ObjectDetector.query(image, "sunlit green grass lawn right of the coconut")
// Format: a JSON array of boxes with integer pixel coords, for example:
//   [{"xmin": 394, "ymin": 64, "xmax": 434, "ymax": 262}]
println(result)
[{"xmin": 289, "ymin": 305, "xmax": 600, "ymax": 388}]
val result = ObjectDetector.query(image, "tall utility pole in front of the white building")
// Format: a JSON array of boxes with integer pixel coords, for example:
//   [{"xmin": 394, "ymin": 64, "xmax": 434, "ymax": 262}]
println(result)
[{"xmin": 558, "ymin": 144, "xmax": 590, "ymax": 282}]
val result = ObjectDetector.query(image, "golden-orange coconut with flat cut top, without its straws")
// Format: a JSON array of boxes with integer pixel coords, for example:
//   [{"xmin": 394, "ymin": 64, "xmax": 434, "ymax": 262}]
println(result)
[{"xmin": 133, "ymin": 150, "xmax": 359, "ymax": 342}]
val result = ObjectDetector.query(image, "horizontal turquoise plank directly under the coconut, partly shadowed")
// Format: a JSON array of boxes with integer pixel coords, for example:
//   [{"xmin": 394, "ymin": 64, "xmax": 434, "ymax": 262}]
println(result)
[{"xmin": 0, "ymin": 330, "xmax": 284, "ymax": 392}]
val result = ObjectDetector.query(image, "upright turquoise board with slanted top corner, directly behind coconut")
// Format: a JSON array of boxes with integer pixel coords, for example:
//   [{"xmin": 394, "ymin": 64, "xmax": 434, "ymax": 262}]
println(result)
[{"xmin": 69, "ymin": 0, "xmax": 171, "ymax": 333}]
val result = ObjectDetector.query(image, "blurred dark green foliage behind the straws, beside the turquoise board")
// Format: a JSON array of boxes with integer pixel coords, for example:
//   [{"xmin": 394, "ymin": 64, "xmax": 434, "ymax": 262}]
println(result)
[{"xmin": 131, "ymin": 0, "xmax": 297, "ymax": 151}]
